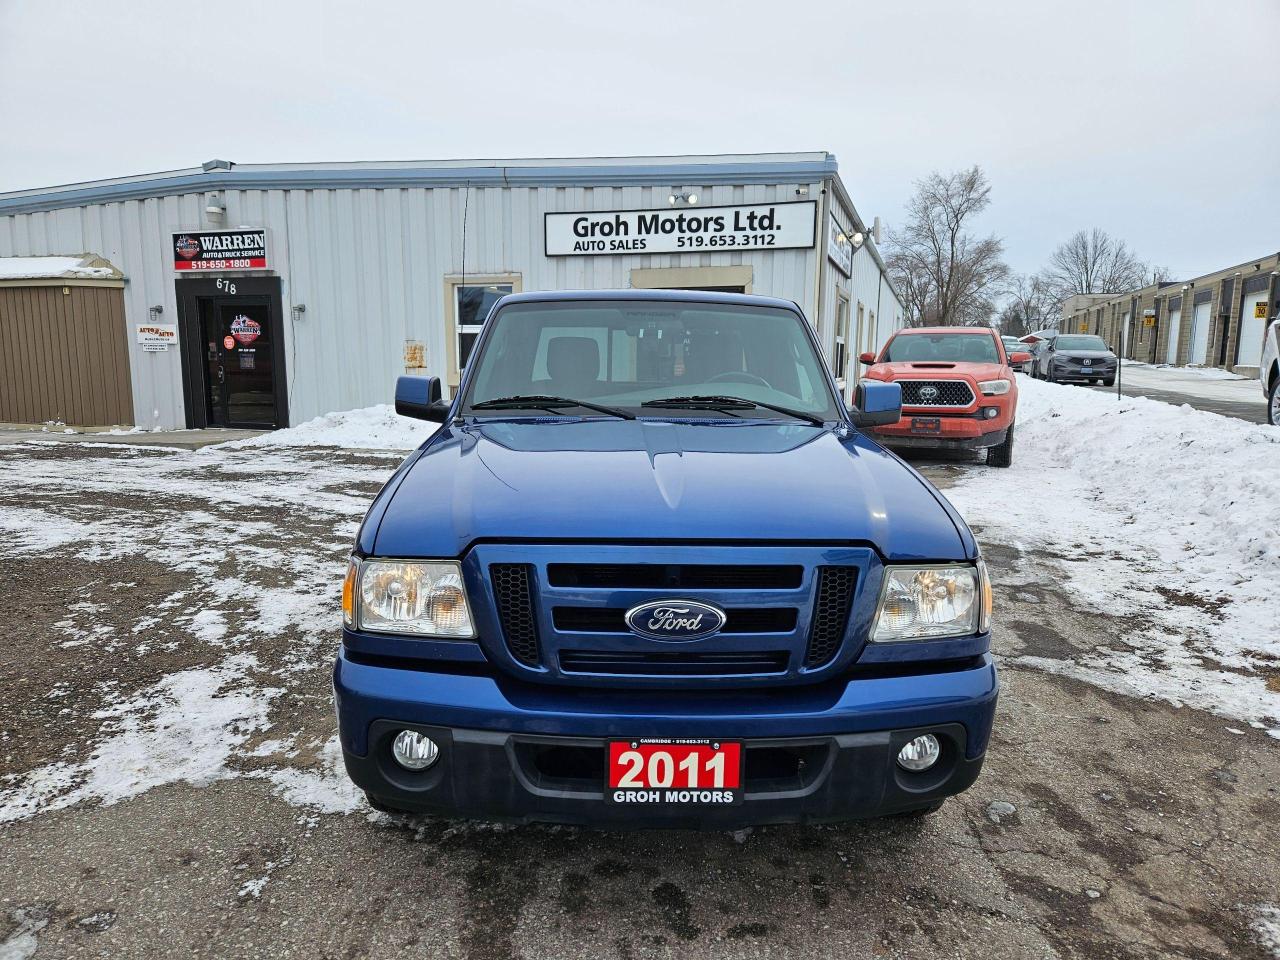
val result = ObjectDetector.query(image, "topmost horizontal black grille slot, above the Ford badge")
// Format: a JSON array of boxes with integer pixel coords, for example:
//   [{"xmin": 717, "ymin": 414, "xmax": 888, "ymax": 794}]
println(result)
[{"xmin": 547, "ymin": 563, "xmax": 804, "ymax": 590}]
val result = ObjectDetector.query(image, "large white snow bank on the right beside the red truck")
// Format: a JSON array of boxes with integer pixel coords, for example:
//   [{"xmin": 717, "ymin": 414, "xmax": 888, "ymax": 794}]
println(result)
[{"xmin": 947, "ymin": 378, "xmax": 1280, "ymax": 737}]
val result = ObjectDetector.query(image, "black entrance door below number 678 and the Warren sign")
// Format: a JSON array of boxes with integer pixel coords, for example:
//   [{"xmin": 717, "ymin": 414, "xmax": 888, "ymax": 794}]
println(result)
[{"xmin": 178, "ymin": 276, "xmax": 288, "ymax": 429}]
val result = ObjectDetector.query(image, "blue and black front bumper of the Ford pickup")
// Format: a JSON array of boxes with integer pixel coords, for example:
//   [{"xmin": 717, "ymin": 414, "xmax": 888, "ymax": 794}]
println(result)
[{"xmin": 334, "ymin": 654, "xmax": 998, "ymax": 829}]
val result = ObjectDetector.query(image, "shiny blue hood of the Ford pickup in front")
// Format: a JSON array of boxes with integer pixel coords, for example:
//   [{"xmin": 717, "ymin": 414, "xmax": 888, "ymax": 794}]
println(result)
[{"xmin": 373, "ymin": 419, "xmax": 972, "ymax": 561}]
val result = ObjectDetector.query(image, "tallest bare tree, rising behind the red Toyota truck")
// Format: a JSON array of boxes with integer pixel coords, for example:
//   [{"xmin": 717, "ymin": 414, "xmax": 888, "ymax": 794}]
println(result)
[{"xmin": 884, "ymin": 165, "xmax": 1009, "ymax": 326}]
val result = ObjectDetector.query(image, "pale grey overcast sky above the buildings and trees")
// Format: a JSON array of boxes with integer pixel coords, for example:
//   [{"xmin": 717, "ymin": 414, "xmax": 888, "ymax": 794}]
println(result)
[{"xmin": 0, "ymin": 0, "xmax": 1280, "ymax": 276}]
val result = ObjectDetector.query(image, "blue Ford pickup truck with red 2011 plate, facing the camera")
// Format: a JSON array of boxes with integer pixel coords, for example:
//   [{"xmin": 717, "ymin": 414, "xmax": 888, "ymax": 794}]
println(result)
[{"xmin": 334, "ymin": 291, "xmax": 998, "ymax": 829}]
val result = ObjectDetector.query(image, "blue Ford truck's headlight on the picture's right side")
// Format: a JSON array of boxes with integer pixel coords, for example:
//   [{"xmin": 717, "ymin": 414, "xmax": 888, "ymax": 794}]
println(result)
[{"xmin": 872, "ymin": 561, "xmax": 989, "ymax": 641}]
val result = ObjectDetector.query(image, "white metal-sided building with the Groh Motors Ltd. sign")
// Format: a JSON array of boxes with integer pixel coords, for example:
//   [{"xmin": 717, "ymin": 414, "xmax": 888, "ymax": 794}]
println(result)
[{"xmin": 0, "ymin": 152, "xmax": 905, "ymax": 429}]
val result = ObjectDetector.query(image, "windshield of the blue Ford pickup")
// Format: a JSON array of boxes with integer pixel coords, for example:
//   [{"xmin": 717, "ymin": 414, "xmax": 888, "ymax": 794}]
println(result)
[{"xmin": 463, "ymin": 301, "xmax": 841, "ymax": 420}]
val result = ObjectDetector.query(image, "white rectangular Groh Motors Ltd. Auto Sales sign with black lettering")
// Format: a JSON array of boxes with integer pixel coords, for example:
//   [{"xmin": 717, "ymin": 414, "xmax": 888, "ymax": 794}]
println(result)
[{"xmin": 543, "ymin": 200, "xmax": 818, "ymax": 257}]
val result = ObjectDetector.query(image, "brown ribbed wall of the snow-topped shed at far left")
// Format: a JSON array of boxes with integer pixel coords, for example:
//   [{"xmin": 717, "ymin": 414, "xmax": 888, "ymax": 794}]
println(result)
[{"xmin": 0, "ymin": 284, "xmax": 133, "ymax": 426}]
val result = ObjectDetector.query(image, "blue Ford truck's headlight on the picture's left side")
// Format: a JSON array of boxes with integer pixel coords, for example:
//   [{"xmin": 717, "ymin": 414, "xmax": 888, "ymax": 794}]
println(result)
[{"xmin": 348, "ymin": 561, "xmax": 475, "ymax": 637}]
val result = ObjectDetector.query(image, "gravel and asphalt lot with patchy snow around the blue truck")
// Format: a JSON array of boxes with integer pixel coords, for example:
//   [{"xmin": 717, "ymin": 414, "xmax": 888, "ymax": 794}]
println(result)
[{"xmin": 0, "ymin": 387, "xmax": 1280, "ymax": 960}]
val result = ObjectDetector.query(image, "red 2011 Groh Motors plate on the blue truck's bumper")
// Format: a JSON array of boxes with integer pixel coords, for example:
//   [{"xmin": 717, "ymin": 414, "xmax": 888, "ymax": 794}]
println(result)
[{"xmin": 605, "ymin": 739, "xmax": 742, "ymax": 805}]
